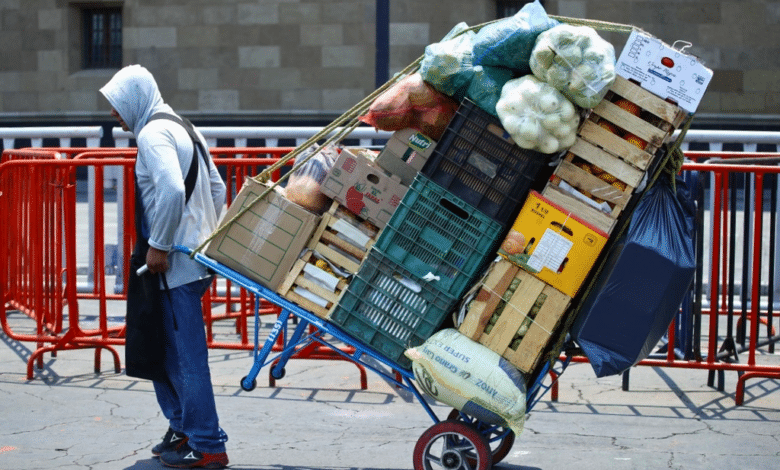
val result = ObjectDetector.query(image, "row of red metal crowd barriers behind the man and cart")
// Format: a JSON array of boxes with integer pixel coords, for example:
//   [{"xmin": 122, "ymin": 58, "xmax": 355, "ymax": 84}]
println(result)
[{"xmin": 0, "ymin": 148, "xmax": 780, "ymax": 404}]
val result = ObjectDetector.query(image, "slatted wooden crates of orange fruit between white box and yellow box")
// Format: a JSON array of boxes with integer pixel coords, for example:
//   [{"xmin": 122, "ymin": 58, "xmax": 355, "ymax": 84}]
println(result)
[{"xmin": 542, "ymin": 77, "xmax": 689, "ymax": 233}]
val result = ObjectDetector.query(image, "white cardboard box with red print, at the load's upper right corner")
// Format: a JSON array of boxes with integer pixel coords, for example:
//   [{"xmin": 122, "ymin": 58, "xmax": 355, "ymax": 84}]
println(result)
[{"xmin": 615, "ymin": 30, "xmax": 712, "ymax": 113}]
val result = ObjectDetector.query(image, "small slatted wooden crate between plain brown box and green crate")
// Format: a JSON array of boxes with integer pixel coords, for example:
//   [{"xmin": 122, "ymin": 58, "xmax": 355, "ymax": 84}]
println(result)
[{"xmin": 277, "ymin": 201, "xmax": 380, "ymax": 318}]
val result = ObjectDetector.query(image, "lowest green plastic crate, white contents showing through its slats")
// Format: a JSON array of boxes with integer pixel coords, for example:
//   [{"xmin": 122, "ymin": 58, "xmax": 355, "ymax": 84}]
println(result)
[{"xmin": 329, "ymin": 249, "xmax": 457, "ymax": 369}]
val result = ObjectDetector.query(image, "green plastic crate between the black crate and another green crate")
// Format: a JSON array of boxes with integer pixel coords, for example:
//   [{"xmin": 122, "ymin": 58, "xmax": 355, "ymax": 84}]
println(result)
[{"xmin": 374, "ymin": 173, "xmax": 503, "ymax": 297}]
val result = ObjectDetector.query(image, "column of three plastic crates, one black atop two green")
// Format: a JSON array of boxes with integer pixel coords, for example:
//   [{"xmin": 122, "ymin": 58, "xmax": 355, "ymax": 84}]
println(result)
[{"xmin": 330, "ymin": 100, "xmax": 548, "ymax": 368}]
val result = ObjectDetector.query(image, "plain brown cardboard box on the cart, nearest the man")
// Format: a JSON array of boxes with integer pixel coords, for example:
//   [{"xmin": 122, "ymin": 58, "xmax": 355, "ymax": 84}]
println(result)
[{"xmin": 205, "ymin": 178, "xmax": 320, "ymax": 290}]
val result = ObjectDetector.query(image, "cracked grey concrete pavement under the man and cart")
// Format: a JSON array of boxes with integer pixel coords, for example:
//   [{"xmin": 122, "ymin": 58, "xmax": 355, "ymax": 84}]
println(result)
[{"xmin": 0, "ymin": 313, "xmax": 780, "ymax": 470}]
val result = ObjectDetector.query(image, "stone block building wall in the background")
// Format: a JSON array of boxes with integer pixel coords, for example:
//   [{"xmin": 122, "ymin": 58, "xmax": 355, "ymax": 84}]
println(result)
[{"xmin": 0, "ymin": 0, "xmax": 780, "ymax": 125}]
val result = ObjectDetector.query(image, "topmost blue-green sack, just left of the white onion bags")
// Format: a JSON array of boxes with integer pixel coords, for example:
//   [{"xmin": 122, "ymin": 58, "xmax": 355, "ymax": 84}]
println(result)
[{"xmin": 473, "ymin": 0, "xmax": 559, "ymax": 75}]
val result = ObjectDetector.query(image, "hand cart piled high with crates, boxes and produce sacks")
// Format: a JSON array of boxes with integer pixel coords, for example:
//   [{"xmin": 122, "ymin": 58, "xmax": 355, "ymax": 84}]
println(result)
[{"xmin": 176, "ymin": 2, "xmax": 711, "ymax": 470}]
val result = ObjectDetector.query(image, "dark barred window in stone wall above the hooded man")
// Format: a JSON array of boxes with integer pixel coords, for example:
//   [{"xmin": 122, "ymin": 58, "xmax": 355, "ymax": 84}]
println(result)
[{"xmin": 82, "ymin": 7, "xmax": 122, "ymax": 69}]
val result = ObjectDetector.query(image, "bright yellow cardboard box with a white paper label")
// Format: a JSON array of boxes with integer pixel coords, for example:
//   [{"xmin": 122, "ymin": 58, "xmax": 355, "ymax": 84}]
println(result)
[{"xmin": 498, "ymin": 191, "xmax": 608, "ymax": 297}]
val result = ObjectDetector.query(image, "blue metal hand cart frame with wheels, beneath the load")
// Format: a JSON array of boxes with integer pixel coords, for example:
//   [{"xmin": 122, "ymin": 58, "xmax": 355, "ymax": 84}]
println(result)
[{"xmin": 173, "ymin": 246, "xmax": 571, "ymax": 470}]
